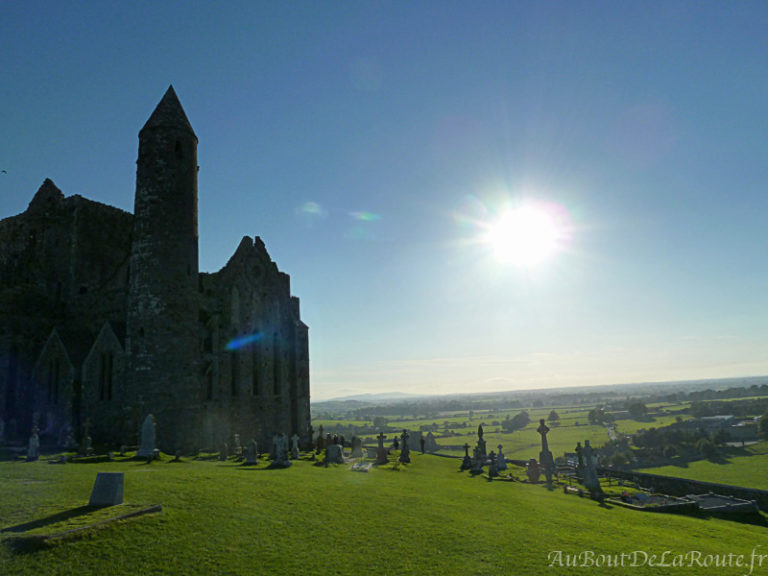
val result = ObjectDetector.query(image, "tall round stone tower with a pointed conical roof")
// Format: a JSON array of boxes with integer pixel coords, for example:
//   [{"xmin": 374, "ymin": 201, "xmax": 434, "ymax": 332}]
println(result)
[{"xmin": 126, "ymin": 86, "xmax": 200, "ymax": 452}]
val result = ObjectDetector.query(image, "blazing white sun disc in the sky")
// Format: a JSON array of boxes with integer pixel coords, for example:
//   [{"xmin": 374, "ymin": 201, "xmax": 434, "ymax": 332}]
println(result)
[{"xmin": 484, "ymin": 204, "xmax": 565, "ymax": 267}]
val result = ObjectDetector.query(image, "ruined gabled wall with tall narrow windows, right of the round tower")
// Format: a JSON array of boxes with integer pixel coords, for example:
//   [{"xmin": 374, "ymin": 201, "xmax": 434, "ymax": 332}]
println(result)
[{"xmin": 201, "ymin": 237, "xmax": 309, "ymax": 446}]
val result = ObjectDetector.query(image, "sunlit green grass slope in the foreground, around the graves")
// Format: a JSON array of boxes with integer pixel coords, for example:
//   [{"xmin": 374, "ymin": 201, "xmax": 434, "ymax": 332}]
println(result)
[{"xmin": 0, "ymin": 454, "xmax": 768, "ymax": 576}]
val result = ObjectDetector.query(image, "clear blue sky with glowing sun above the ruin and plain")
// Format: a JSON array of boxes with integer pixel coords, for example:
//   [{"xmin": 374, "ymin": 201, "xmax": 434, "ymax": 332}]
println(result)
[{"xmin": 0, "ymin": 0, "xmax": 768, "ymax": 399}]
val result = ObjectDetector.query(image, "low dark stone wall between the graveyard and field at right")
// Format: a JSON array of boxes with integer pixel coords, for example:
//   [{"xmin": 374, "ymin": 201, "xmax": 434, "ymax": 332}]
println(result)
[{"xmin": 599, "ymin": 468, "xmax": 768, "ymax": 512}]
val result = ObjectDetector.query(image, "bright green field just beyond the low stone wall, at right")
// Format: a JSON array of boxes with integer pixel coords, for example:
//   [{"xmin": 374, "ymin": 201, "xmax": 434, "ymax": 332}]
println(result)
[{"xmin": 639, "ymin": 442, "xmax": 768, "ymax": 490}]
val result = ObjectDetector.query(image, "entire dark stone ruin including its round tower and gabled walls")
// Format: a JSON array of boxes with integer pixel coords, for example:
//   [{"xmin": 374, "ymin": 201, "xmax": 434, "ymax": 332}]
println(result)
[{"xmin": 0, "ymin": 87, "xmax": 310, "ymax": 453}]
